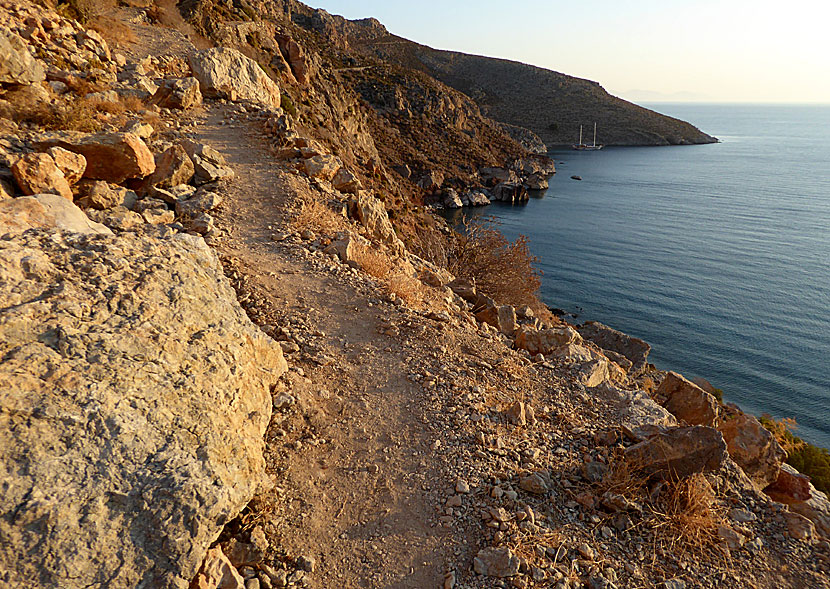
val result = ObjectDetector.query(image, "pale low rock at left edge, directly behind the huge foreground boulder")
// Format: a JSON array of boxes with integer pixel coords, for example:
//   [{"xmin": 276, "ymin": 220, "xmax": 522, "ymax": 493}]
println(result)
[{"xmin": 0, "ymin": 194, "xmax": 112, "ymax": 235}]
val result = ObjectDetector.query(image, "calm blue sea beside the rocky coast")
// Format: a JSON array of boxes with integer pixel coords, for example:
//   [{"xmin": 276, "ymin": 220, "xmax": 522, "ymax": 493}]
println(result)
[{"xmin": 455, "ymin": 103, "xmax": 830, "ymax": 448}]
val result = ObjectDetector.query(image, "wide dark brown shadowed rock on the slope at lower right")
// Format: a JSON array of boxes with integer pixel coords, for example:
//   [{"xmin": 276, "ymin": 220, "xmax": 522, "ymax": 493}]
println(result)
[{"xmin": 625, "ymin": 426, "xmax": 727, "ymax": 479}]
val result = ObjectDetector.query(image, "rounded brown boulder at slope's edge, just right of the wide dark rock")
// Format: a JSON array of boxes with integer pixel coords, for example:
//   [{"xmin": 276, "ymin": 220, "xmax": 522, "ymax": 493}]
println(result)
[{"xmin": 718, "ymin": 412, "xmax": 787, "ymax": 489}]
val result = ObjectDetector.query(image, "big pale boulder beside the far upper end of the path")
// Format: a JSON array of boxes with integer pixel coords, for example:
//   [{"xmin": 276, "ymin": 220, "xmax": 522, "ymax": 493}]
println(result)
[{"xmin": 190, "ymin": 47, "xmax": 280, "ymax": 107}]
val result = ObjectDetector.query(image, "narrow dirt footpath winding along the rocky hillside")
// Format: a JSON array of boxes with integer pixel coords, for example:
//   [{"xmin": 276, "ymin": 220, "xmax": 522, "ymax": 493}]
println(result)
[{"xmin": 193, "ymin": 112, "xmax": 462, "ymax": 588}]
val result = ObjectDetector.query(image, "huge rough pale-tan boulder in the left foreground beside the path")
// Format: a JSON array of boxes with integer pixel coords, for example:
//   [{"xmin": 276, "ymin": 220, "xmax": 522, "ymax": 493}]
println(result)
[{"xmin": 0, "ymin": 231, "xmax": 286, "ymax": 589}]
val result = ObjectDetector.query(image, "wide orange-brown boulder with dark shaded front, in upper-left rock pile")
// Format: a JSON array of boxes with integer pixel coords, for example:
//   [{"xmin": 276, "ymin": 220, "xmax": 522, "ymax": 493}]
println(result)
[{"xmin": 36, "ymin": 133, "xmax": 156, "ymax": 184}]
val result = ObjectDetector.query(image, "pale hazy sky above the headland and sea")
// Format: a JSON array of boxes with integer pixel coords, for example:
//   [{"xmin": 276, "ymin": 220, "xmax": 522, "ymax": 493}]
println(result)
[{"xmin": 306, "ymin": 0, "xmax": 830, "ymax": 103}]
